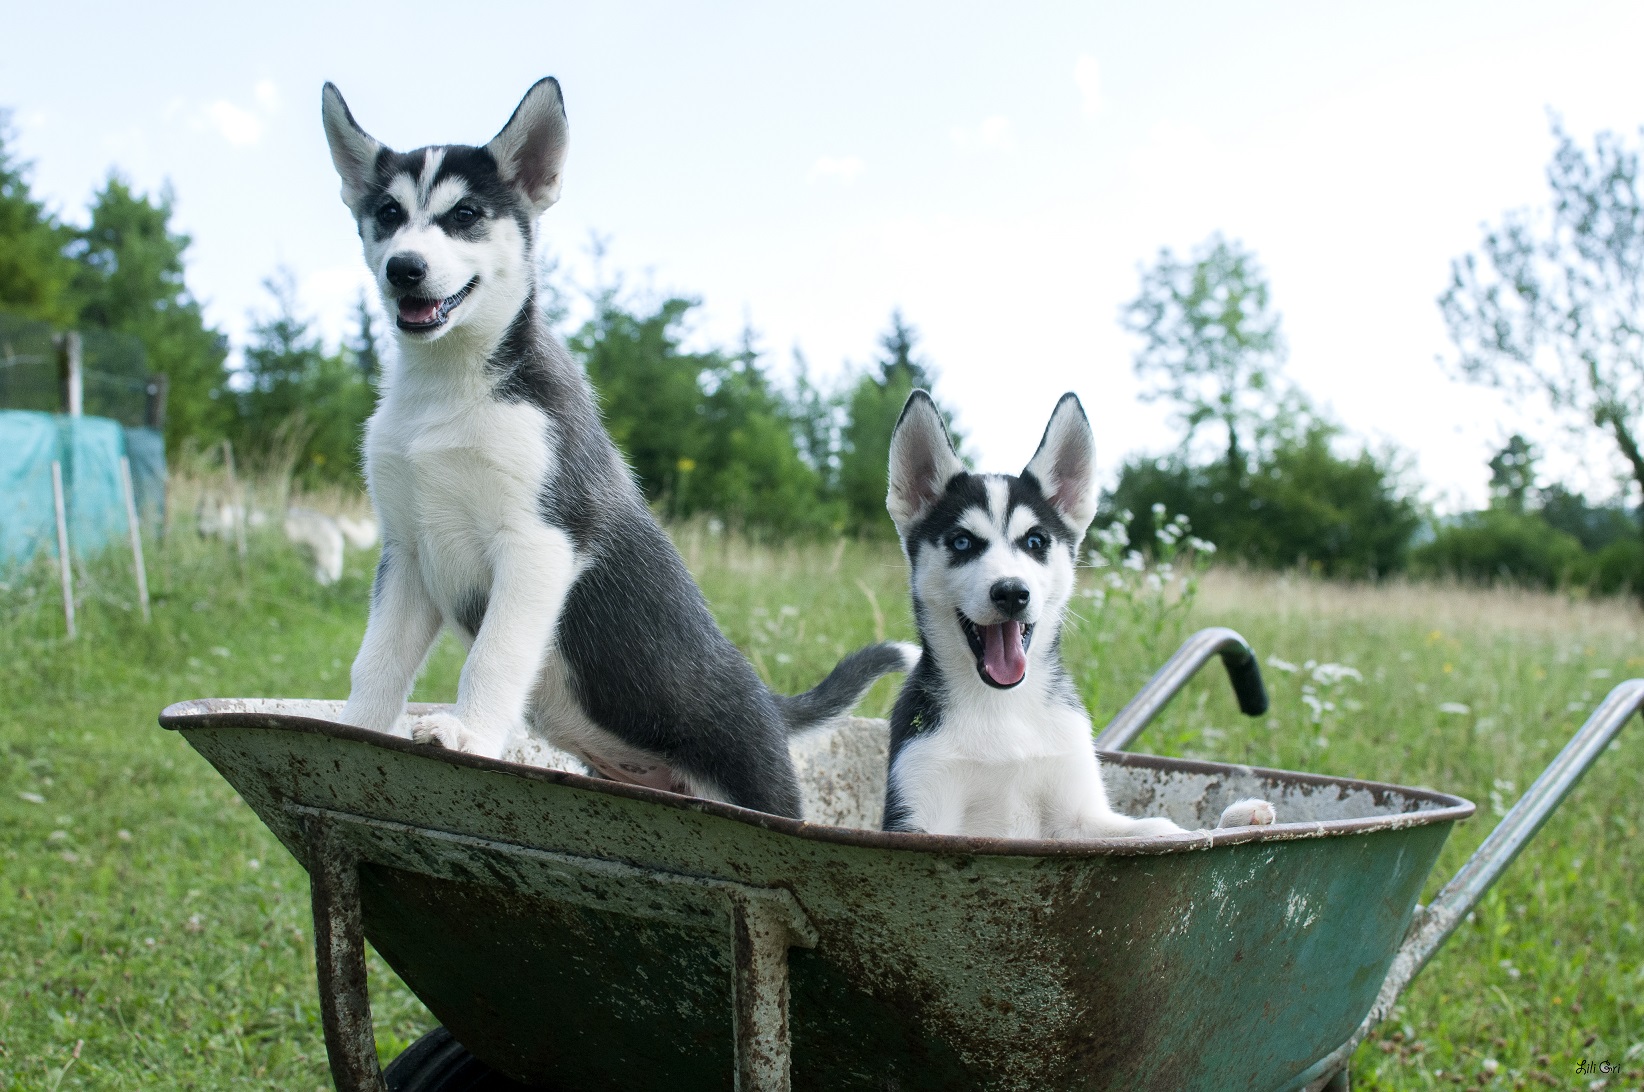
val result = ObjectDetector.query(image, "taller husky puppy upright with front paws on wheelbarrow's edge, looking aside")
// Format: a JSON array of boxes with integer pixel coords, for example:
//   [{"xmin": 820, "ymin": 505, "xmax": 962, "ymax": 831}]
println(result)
[{"xmin": 322, "ymin": 79, "xmax": 912, "ymax": 816}]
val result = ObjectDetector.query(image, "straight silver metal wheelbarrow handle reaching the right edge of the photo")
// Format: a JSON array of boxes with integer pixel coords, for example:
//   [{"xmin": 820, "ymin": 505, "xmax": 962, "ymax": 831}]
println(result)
[{"xmin": 1305, "ymin": 679, "xmax": 1644, "ymax": 1087}]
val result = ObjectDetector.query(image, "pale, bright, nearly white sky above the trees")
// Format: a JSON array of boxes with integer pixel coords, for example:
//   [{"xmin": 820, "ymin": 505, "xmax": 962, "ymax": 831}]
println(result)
[{"xmin": 0, "ymin": 0, "xmax": 1644, "ymax": 510}]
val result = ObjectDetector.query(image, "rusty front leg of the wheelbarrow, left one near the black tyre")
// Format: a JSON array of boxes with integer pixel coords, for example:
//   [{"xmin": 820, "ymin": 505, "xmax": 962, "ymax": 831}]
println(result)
[{"xmin": 304, "ymin": 816, "xmax": 388, "ymax": 1092}]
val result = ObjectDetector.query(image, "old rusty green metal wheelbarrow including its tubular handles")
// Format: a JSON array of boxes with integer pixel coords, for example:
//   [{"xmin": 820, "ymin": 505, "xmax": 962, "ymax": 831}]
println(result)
[{"xmin": 161, "ymin": 630, "xmax": 1644, "ymax": 1092}]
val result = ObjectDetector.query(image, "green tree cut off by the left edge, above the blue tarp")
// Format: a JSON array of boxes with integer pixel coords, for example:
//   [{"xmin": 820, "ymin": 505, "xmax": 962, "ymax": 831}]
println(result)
[{"xmin": 0, "ymin": 110, "xmax": 76, "ymax": 327}]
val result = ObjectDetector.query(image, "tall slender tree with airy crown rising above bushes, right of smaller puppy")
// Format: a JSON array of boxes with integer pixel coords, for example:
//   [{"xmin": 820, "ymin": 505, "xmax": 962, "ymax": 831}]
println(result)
[{"xmin": 1121, "ymin": 235, "xmax": 1284, "ymax": 480}]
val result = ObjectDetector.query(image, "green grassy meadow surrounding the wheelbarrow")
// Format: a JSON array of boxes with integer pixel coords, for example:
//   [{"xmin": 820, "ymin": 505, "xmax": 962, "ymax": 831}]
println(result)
[{"xmin": 0, "ymin": 486, "xmax": 1644, "ymax": 1090}]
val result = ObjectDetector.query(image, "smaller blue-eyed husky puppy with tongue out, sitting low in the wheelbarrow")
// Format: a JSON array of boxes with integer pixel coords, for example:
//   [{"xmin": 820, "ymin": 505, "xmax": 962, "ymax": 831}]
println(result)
[{"xmin": 884, "ymin": 390, "xmax": 1274, "ymax": 839}]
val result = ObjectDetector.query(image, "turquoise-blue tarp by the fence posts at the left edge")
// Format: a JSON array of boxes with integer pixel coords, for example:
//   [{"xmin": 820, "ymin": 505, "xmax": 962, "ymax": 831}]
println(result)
[{"xmin": 0, "ymin": 410, "xmax": 166, "ymax": 566}]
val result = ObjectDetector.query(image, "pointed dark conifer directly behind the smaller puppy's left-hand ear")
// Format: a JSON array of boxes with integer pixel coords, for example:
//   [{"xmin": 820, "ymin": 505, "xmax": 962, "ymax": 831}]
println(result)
[{"xmin": 838, "ymin": 311, "xmax": 960, "ymax": 534}]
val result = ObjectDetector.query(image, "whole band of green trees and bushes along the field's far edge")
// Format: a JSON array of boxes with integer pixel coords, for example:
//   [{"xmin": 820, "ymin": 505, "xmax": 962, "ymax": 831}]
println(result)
[{"xmin": 0, "ymin": 108, "xmax": 1644, "ymax": 590}]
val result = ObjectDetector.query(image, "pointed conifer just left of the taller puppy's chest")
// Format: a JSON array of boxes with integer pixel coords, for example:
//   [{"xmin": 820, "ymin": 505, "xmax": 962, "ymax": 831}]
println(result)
[{"xmin": 230, "ymin": 270, "xmax": 373, "ymax": 484}]
